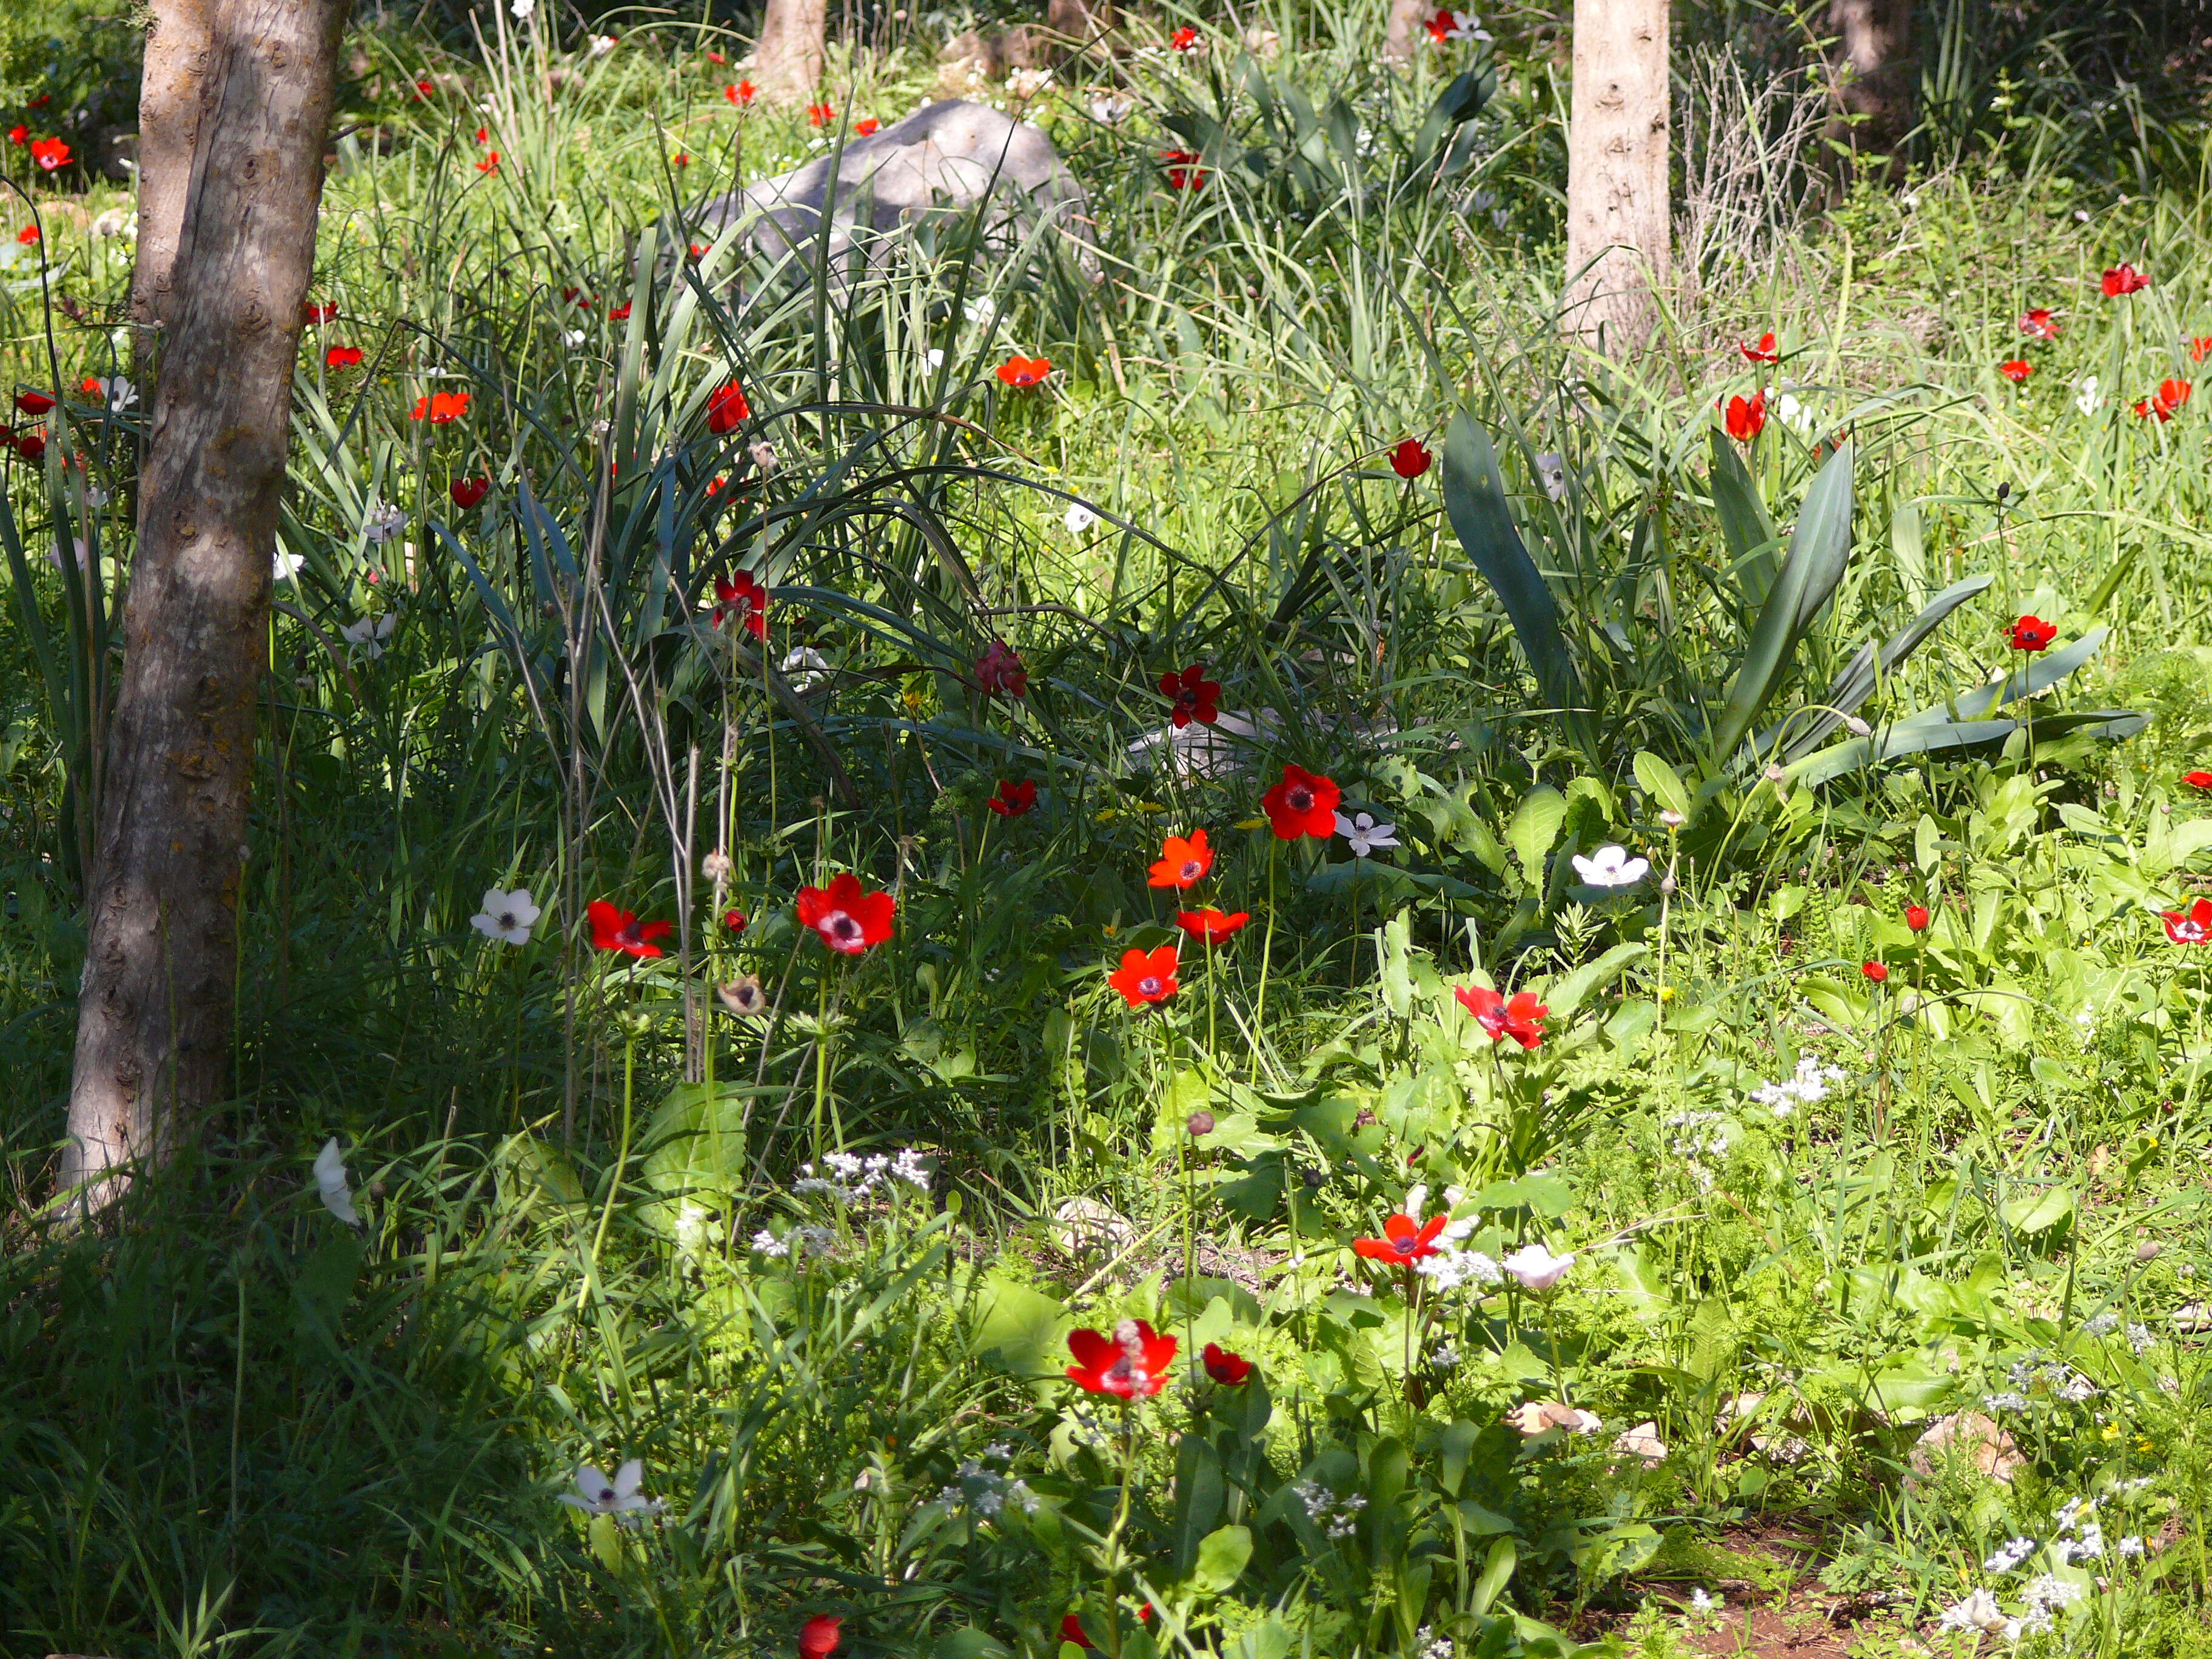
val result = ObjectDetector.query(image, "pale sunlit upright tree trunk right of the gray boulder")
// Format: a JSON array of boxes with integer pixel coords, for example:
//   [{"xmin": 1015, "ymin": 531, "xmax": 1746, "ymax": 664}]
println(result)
[{"xmin": 1560, "ymin": 0, "xmax": 1670, "ymax": 352}]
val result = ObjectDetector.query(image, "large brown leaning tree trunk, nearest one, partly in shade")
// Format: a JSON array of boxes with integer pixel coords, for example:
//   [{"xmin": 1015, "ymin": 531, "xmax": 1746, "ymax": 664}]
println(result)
[{"xmin": 62, "ymin": 0, "xmax": 345, "ymax": 1210}]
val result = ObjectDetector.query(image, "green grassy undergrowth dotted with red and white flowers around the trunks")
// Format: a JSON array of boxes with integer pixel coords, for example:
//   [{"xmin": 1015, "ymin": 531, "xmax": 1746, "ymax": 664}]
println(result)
[{"xmin": 0, "ymin": 9, "xmax": 2212, "ymax": 1659}]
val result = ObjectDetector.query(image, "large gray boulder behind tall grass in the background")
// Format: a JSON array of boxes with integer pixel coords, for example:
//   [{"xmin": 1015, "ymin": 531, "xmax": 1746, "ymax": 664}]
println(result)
[{"xmin": 699, "ymin": 98, "xmax": 1090, "ymax": 266}]
